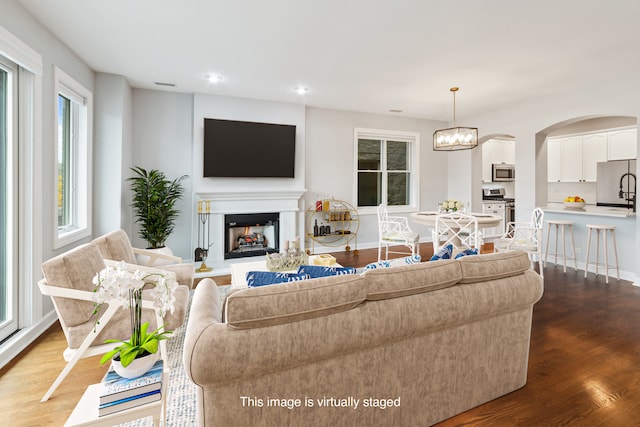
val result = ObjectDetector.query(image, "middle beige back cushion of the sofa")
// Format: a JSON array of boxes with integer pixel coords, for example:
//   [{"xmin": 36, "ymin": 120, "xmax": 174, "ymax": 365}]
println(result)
[{"xmin": 363, "ymin": 260, "xmax": 462, "ymax": 300}]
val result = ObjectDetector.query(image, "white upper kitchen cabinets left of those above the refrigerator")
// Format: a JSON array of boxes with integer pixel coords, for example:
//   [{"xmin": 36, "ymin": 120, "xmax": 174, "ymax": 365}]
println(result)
[{"xmin": 547, "ymin": 132, "xmax": 607, "ymax": 182}]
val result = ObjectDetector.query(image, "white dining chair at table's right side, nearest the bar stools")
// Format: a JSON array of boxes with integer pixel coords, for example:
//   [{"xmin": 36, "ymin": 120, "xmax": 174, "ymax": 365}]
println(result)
[{"xmin": 493, "ymin": 208, "xmax": 544, "ymax": 276}]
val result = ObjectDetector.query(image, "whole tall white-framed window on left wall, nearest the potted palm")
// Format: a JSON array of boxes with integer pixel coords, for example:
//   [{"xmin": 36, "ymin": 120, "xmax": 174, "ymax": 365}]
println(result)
[{"xmin": 54, "ymin": 68, "xmax": 92, "ymax": 247}]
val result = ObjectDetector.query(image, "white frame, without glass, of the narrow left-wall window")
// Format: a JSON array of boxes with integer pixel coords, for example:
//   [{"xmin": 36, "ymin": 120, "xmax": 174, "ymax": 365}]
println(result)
[{"xmin": 52, "ymin": 67, "xmax": 93, "ymax": 249}]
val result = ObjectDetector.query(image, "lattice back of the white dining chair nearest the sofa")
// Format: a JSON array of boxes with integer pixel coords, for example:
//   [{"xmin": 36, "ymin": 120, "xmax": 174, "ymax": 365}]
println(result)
[{"xmin": 433, "ymin": 212, "xmax": 482, "ymax": 253}]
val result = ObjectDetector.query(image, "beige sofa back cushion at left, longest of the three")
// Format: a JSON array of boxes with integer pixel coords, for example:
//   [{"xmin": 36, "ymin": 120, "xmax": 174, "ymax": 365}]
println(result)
[{"xmin": 225, "ymin": 274, "xmax": 367, "ymax": 329}]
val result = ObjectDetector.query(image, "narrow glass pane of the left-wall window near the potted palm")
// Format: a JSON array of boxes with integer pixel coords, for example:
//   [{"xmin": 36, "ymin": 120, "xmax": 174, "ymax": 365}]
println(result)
[{"xmin": 57, "ymin": 95, "xmax": 71, "ymax": 227}]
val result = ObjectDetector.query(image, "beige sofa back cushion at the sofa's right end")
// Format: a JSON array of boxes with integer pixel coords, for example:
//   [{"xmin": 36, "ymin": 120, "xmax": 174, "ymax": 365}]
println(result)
[{"xmin": 459, "ymin": 251, "xmax": 531, "ymax": 283}]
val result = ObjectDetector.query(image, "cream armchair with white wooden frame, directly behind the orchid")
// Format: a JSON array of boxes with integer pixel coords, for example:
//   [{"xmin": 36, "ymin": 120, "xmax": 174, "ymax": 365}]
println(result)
[{"xmin": 38, "ymin": 243, "xmax": 189, "ymax": 402}]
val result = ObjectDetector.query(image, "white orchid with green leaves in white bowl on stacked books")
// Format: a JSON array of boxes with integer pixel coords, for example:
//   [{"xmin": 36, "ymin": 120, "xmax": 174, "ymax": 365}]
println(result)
[{"xmin": 92, "ymin": 262, "xmax": 178, "ymax": 378}]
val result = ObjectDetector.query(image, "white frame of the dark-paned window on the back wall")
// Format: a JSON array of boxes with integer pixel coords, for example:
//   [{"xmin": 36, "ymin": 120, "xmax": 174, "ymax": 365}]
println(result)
[{"xmin": 353, "ymin": 128, "xmax": 420, "ymax": 214}]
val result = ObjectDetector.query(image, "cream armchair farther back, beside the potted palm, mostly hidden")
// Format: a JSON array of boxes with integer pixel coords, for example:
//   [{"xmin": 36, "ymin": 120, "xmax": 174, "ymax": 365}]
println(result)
[{"xmin": 92, "ymin": 230, "xmax": 195, "ymax": 289}]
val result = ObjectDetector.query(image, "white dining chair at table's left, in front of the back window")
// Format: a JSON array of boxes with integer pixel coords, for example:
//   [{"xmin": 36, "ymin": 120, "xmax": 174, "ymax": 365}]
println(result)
[{"xmin": 378, "ymin": 205, "xmax": 420, "ymax": 261}]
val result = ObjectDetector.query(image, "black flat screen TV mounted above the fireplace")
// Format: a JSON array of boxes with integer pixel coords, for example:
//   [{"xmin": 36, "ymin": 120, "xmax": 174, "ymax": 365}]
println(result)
[{"xmin": 203, "ymin": 118, "xmax": 296, "ymax": 178}]
